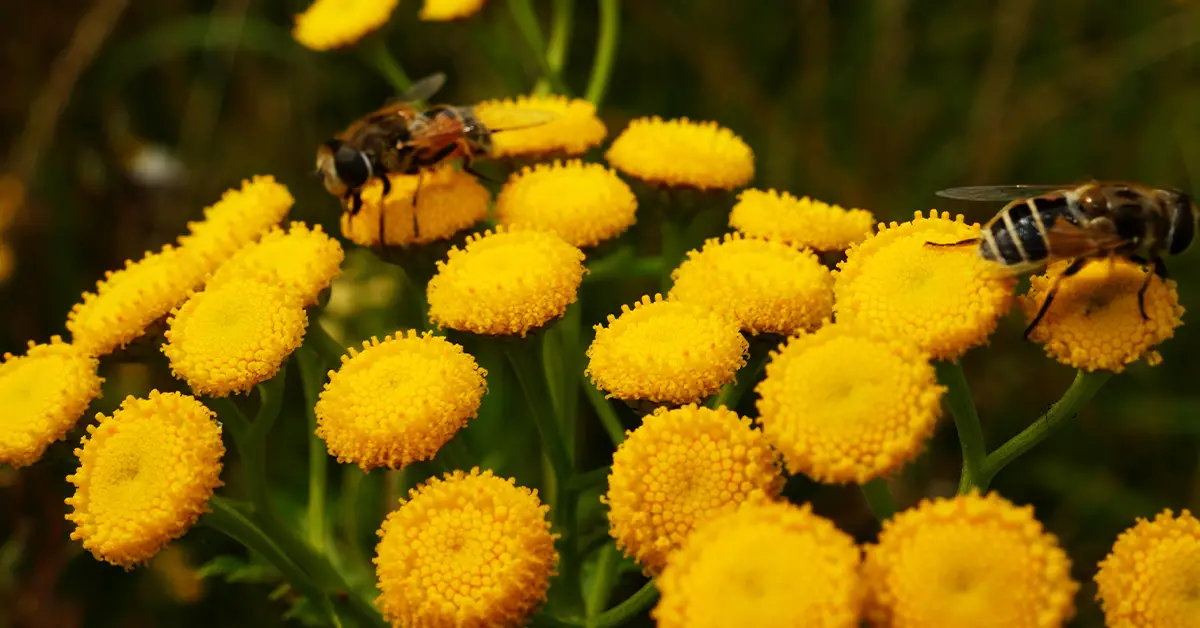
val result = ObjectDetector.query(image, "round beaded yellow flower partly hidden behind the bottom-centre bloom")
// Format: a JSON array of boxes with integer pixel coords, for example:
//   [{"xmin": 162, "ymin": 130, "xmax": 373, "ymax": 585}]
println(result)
[{"xmin": 604, "ymin": 405, "xmax": 784, "ymax": 574}]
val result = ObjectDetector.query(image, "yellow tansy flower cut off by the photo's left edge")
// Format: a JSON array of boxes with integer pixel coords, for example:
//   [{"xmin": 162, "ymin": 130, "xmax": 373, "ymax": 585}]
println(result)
[{"xmin": 0, "ymin": 336, "xmax": 103, "ymax": 467}]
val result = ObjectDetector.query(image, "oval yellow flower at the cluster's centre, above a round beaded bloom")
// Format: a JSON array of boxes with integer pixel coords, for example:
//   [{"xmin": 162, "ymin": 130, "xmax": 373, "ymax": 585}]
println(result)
[{"xmin": 584, "ymin": 294, "xmax": 750, "ymax": 405}]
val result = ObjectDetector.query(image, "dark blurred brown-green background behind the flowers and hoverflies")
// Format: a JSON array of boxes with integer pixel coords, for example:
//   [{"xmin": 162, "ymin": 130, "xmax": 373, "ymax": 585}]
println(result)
[{"xmin": 0, "ymin": 0, "xmax": 1200, "ymax": 628}]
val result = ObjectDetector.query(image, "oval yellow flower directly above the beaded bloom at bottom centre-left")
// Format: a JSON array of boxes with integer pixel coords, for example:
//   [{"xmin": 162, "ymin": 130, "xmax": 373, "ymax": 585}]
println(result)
[{"xmin": 317, "ymin": 330, "xmax": 487, "ymax": 471}]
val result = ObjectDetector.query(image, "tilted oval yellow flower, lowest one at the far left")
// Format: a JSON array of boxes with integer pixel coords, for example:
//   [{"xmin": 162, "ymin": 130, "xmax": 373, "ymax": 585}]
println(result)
[{"xmin": 66, "ymin": 390, "xmax": 224, "ymax": 568}]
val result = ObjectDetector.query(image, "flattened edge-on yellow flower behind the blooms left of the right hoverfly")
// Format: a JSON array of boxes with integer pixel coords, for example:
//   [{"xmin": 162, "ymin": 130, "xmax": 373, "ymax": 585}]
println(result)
[{"xmin": 730, "ymin": 190, "xmax": 875, "ymax": 251}]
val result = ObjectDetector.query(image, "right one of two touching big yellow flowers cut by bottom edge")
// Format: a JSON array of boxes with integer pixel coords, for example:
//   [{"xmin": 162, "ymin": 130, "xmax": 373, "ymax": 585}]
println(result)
[{"xmin": 863, "ymin": 494, "xmax": 1079, "ymax": 628}]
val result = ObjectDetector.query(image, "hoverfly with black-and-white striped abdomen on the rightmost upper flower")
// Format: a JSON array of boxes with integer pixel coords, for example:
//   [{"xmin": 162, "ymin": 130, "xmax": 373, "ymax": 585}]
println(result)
[{"xmin": 926, "ymin": 181, "xmax": 1200, "ymax": 339}]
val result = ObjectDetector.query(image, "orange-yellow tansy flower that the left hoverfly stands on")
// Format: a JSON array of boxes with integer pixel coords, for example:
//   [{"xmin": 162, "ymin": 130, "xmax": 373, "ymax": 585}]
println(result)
[{"xmin": 342, "ymin": 165, "xmax": 492, "ymax": 246}]
